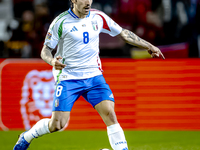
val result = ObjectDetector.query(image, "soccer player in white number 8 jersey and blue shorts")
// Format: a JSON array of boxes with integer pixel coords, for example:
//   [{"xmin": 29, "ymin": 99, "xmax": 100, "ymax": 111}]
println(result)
[{"xmin": 14, "ymin": 0, "xmax": 164, "ymax": 150}]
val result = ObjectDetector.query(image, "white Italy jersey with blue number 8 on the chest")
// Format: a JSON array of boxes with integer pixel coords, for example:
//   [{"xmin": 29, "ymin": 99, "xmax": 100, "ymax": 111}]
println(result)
[{"xmin": 44, "ymin": 9, "xmax": 122, "ymax": 81}]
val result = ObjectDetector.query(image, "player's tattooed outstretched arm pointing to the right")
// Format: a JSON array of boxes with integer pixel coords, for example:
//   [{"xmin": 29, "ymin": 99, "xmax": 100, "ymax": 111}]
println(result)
[{"xmin": 120, "ymin": 29, "xmax": 165, "ymax": 59}]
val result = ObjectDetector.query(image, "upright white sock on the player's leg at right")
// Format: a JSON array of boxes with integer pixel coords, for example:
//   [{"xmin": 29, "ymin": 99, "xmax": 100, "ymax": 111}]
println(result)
[{"xmin": 107, "ymin": 124, "xmax": 128, "ymax": 150}]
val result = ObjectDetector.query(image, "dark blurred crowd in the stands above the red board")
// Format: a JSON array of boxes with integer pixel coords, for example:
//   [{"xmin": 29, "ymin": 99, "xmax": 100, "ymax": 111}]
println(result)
[{"xmin": 0, "ymin": 0, "xmax": 200, "ymax": 58}]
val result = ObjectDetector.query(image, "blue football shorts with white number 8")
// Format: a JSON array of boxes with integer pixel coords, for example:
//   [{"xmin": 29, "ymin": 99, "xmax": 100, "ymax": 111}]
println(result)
[{"xmin": 53, "ymin": 75, "xmax": 114, "ymax": 111}]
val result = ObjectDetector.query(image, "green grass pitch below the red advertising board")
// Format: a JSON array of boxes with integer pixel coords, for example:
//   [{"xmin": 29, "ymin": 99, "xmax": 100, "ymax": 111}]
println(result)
[{"xmin": 0, "ymin": 131, "xmax": 200, "ymax": 150}]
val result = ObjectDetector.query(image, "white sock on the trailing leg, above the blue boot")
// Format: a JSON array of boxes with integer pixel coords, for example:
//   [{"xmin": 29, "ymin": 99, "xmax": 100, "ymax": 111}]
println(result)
[{"xmin": 24, "ymin": 119, "xmax": 50, "ymax": 143}]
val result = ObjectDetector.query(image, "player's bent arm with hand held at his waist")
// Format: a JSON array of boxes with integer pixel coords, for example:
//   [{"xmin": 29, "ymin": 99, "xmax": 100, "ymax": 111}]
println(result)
[{"xmin": 40, "ymin": 45, "xmax": 66, "ymax": 70}]
